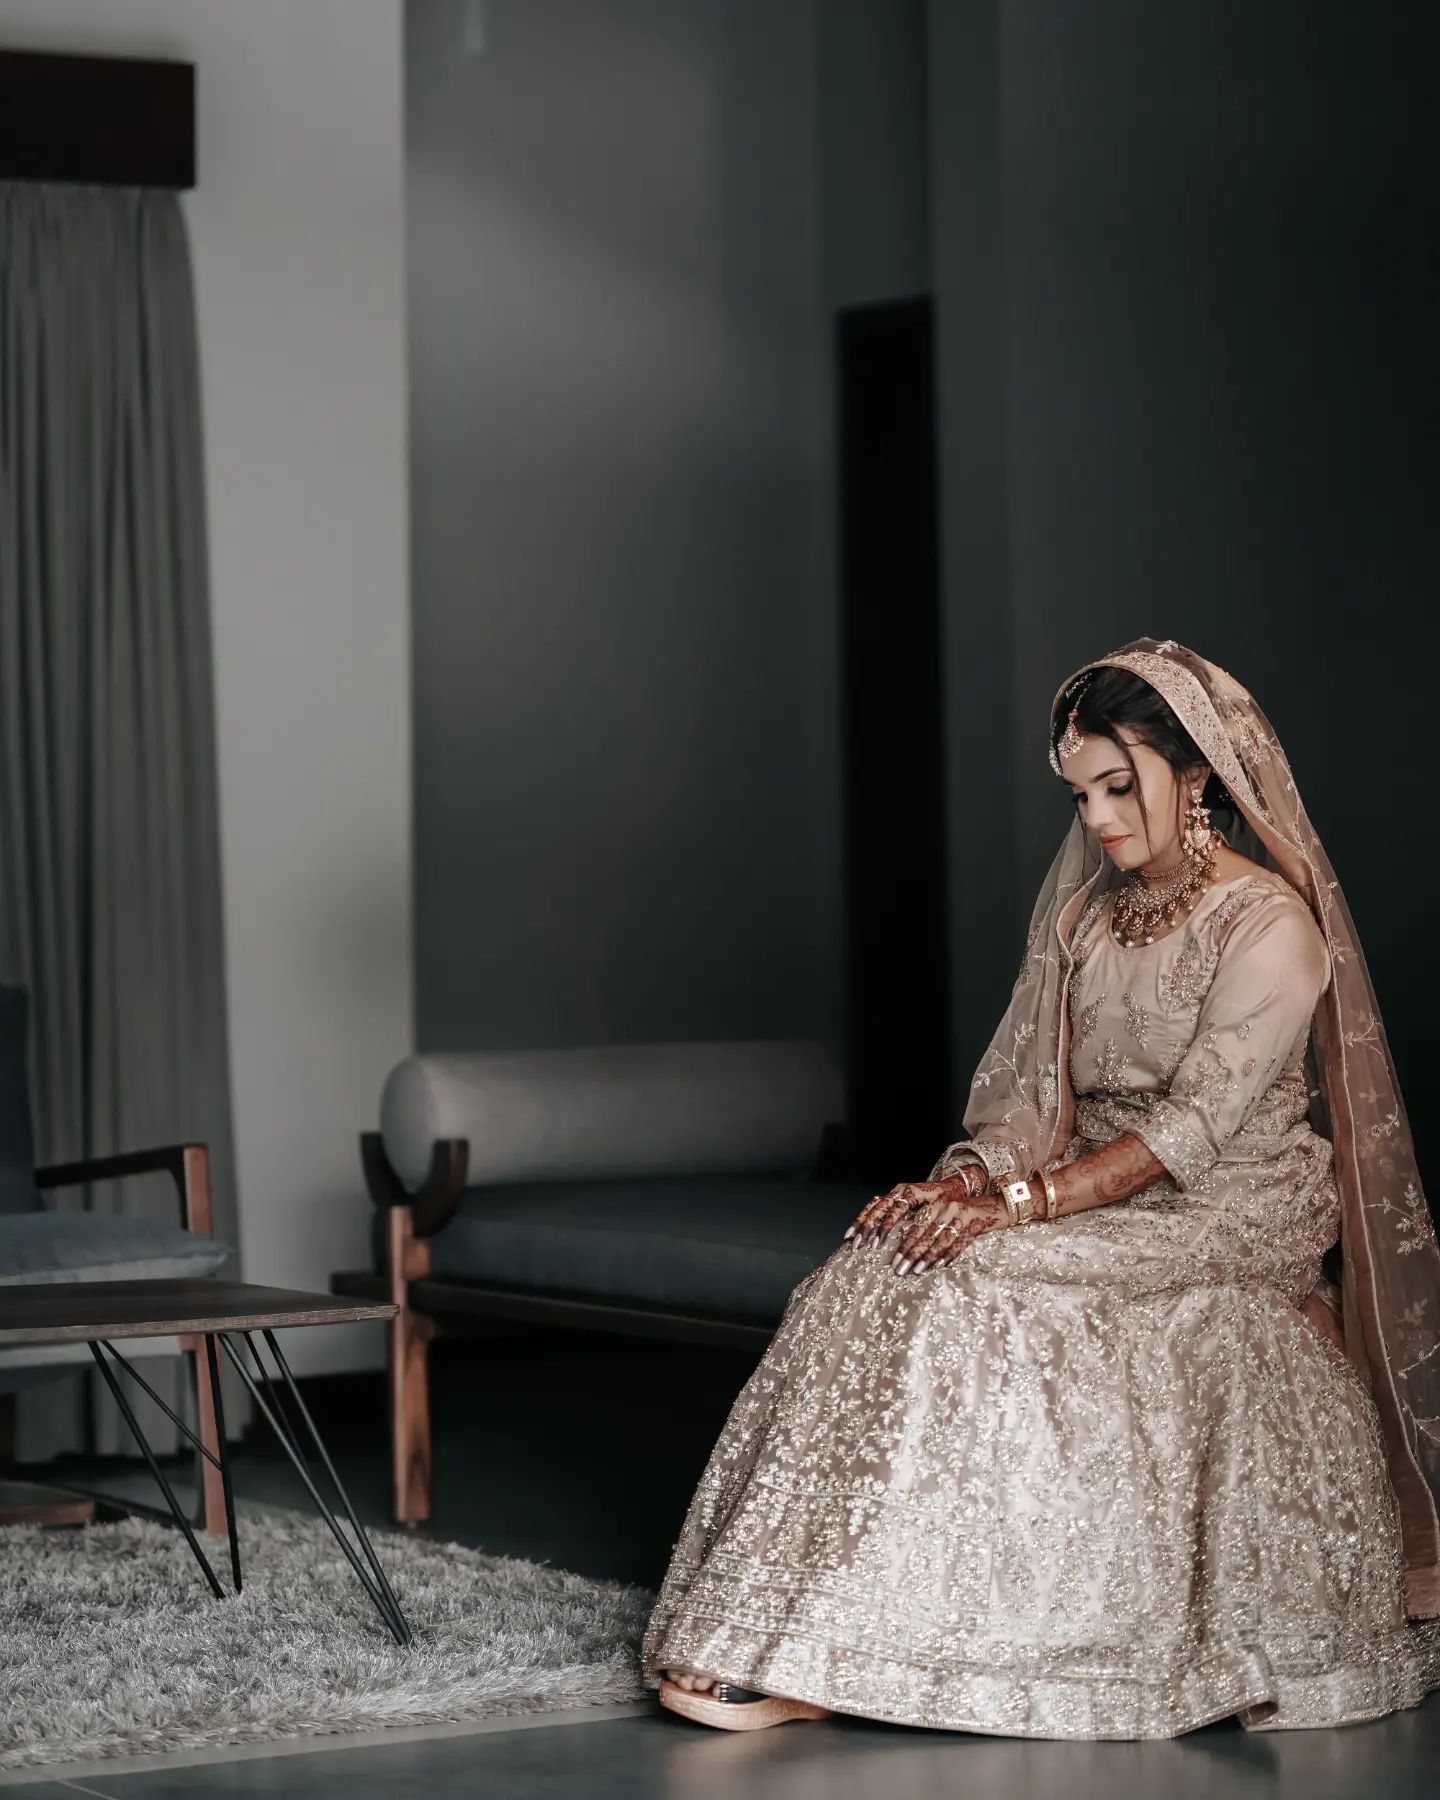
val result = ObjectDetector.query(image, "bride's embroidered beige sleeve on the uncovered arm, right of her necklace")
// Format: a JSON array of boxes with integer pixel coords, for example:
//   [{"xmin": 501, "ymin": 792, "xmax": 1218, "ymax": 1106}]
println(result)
[{"xmin": 1130, "ymin": 889, "xmax": 1330, "ymax": 1192}]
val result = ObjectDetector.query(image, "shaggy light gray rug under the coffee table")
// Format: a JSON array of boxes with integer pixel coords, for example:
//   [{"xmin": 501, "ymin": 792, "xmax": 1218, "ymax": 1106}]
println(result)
[{"xmin": 0, "ymin": 1507, "xmax": 655, "ymax": 1769}]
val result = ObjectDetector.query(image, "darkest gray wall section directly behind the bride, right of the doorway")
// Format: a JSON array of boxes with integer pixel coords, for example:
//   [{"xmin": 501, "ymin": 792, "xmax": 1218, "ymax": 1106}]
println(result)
[{"xmin": 931, "ymin": 0, "xmax": 1440, "ymax": 1166}]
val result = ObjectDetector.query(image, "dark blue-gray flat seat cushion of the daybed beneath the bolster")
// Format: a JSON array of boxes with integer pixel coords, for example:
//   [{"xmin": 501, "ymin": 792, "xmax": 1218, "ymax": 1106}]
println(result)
[{"xmin": 373, "ymin": 1175, "xmax": 873, "ymax": 1323}]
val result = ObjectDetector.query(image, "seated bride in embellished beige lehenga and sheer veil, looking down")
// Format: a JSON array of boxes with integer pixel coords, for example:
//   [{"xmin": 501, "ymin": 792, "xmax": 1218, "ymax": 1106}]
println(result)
[{"xmin": 643, "ymin": 637, "xmax": 1440, "ymax": 1739}]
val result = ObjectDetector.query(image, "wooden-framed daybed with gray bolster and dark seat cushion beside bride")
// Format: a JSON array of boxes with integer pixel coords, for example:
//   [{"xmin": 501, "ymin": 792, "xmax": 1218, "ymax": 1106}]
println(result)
[{"xmin": 329, "ymin": 1042, "xmax": 871, "ymax": 1523}]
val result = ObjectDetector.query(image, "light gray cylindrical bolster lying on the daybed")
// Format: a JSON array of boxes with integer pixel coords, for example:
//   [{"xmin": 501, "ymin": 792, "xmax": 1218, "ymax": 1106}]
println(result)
[{"xmin": 380, "ymin": 1040, "xmax": 844, "ymax": 1190}]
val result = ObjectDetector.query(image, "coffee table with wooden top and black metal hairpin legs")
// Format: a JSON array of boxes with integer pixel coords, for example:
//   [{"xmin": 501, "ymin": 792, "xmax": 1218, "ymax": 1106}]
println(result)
[{"xmin": 0, "ymin": 1276, "xmax": 414, "ymax": 1645}]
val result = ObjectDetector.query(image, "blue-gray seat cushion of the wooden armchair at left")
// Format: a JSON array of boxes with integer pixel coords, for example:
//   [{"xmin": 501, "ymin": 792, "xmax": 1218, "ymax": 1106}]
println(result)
[{"xmin": 0, "ymin": 1211, "xmax": 230, "ymax": 1283}]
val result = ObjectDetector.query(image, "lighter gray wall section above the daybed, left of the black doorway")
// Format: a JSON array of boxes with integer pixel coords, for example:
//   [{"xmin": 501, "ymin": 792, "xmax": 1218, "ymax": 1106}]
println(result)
[{"xmin": 407, "ymin": 0, "xmax": 839, "ymax": 1048}]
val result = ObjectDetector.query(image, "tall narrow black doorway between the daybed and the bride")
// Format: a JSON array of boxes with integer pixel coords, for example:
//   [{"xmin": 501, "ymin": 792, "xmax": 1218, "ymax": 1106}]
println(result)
[{"xmin": 839, "ymin": 299, "xmax": 954, "ymax": 1186}]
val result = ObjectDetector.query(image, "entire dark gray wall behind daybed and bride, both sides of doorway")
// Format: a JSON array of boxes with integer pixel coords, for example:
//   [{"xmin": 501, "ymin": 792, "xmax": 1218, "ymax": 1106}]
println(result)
[{"xmin": 409, "ymin": 0, "xmax": 1436, "ymax": 1166}]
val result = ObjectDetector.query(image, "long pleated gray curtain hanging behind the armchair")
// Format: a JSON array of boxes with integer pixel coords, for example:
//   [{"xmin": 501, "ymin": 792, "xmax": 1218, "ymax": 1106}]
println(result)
[{"xmin": 0, "ymin": 184, "xmax": 248, "ymax": 1460}]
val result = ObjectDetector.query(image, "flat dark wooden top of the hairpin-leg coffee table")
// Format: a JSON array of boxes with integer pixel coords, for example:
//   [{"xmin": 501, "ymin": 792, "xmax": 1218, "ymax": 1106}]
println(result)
[{"xmin": 0, "ymin": 1276, "xmax": 398, "ymax": 1350}]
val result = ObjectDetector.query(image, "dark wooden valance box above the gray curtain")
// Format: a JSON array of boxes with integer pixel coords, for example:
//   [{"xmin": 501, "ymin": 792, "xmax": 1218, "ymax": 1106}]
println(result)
[{"xmin": 0, "ymin": 50, "xmax": 194, "ymax": 187}]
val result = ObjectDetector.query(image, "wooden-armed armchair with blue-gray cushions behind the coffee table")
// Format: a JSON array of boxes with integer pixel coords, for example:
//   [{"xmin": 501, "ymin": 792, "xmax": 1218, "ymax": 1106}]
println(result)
[{"xmin": 0, "ymin": 986, "xmax": 229, "ymax": 1532}]
